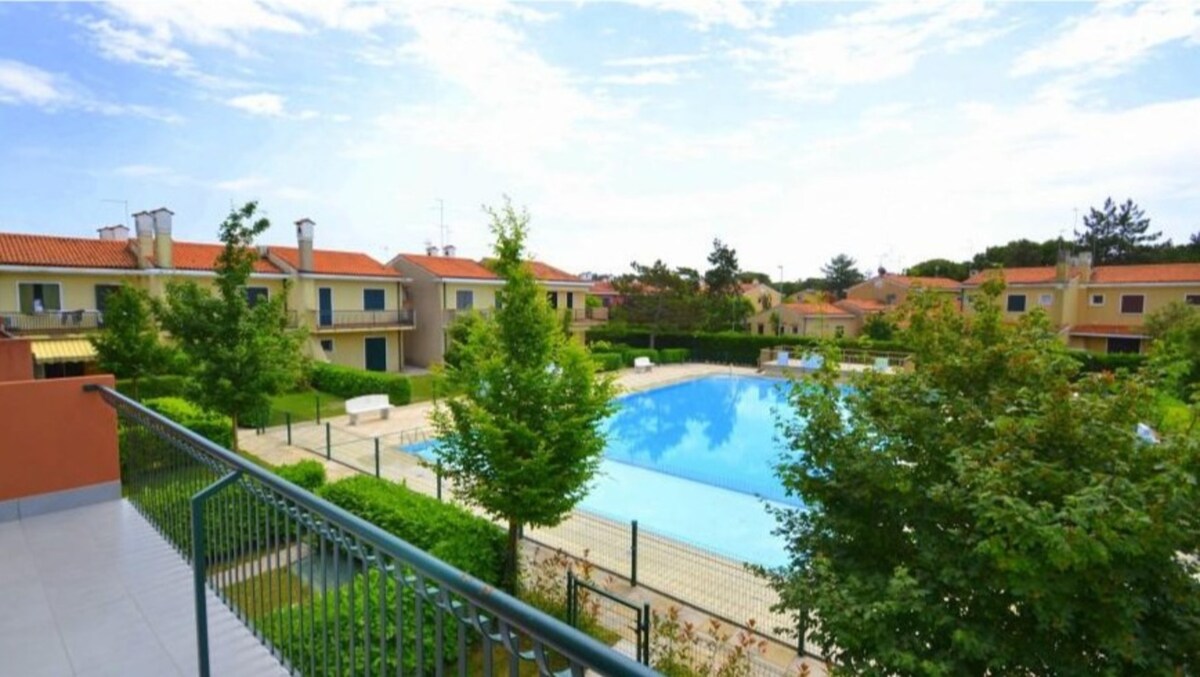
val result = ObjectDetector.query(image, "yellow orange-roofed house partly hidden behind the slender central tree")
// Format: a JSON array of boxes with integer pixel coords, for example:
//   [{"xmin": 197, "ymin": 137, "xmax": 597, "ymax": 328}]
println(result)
[{"xmin": 389, "ymin": 247, "xmax": 595, "ymax": 367}]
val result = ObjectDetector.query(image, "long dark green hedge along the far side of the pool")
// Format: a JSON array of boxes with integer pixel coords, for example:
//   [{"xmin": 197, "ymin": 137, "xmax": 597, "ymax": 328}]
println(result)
[{"xmin": 587, "ymin": 326, "xmax": 908, "ymax": 366}]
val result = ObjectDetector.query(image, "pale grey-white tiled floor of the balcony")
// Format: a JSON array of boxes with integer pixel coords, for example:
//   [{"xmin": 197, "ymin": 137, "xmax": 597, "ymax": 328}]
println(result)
[{"xmin": 0, "ymin": 501, "xmax": 287, "ymax": 677}]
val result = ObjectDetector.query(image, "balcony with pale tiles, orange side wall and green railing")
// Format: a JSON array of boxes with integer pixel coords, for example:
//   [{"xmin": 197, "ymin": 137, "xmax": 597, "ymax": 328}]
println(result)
[{"xmin": 0, "ymin": 342, "xmax": 654, "ymax": 677}]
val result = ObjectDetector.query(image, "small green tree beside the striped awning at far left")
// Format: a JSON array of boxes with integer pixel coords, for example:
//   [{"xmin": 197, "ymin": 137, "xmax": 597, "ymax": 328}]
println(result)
[{"xmin": 88, "ymin": 284, "xmax": 168, "ymax": 400}]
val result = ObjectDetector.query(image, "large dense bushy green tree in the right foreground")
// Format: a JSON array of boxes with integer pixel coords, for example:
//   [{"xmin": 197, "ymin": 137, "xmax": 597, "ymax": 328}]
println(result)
[{"xmin": 772, "ymin": 281, "xmax": 1200, "ymax": 675}]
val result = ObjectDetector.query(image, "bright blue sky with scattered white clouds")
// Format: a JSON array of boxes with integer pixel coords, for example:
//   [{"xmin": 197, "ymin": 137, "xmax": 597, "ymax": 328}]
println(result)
[{"xmin": 0, "ymin": 0, "xmax": 1200, "ymax": 280}]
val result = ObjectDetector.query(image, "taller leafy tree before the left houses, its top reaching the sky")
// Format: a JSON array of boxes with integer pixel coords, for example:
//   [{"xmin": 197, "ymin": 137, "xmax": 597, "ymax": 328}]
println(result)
[{"xmin": 160, "ymin": 202, "xmax": 304, "ymax": 449}]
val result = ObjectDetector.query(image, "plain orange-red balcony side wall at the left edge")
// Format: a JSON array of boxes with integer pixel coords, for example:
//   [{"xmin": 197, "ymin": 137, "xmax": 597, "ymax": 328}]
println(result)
[{"xmin": 0, "ymin": 375, "xmax": 120, "ymax": 501}]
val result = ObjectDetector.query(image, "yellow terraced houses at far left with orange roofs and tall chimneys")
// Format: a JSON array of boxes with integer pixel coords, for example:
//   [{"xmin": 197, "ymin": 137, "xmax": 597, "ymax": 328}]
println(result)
[{"xmin": 0, "ymin": 208, "xmax": 415, "ymax": 377}]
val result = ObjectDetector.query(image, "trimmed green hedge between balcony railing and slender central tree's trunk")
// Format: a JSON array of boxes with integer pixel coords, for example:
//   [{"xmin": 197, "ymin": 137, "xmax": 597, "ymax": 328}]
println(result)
[{"xmin": 317, "ymin": 475, "xmax": 506, "ymax": 585}]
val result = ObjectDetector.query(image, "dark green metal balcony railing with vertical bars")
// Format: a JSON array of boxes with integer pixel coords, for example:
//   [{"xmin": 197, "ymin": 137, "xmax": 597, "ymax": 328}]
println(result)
[{"xmin": 85, "ymin": 385, "xmax": 655, "ymax": 677}]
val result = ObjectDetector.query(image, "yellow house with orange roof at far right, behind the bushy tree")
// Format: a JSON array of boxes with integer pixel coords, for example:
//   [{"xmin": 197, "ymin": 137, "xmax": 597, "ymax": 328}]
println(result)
[{"xmin": 964, "ymin": 253, "xmax": 1200, "ymax": 353}]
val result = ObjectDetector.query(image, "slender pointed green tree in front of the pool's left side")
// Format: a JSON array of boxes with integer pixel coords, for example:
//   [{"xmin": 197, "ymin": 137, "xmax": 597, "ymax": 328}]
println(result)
[{"xmin": 432, "ymin": 202, "xmax": 614, "ymax": 592}]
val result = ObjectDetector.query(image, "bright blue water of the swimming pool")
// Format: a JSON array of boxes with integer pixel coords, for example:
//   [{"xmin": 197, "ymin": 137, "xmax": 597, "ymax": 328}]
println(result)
[{"xmin": 407, "ymin": 376, "xmax": 800, "ymax": 567}]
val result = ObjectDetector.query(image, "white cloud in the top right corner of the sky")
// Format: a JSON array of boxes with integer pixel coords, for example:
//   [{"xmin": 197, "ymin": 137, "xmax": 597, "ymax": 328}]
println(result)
[{"xmin": 1012, "ymin": 0, "xmax": 1200, "ymax": 77}]
